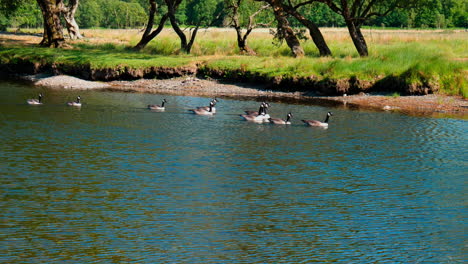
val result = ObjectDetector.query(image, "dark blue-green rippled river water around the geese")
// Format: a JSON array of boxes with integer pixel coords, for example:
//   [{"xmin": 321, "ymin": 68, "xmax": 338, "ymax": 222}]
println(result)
[{"xmin": 0, "ymin": 83, "xmax": 468, "ymax": 263}]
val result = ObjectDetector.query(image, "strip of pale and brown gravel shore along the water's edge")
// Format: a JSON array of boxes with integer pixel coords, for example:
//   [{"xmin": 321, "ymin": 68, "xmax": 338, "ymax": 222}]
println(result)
[{"xmin": 14, "ymin": 72, "xmax": 468, "ymax": 119}]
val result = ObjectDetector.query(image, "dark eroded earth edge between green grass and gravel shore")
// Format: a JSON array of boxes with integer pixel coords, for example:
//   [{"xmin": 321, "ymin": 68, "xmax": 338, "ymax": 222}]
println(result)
[{"xmin": 0, "ymin": 60, "xmax": 439, "ymax": 96}]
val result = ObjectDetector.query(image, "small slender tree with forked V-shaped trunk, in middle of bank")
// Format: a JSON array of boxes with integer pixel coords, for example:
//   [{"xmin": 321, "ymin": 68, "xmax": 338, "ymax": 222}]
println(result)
[{"xmin": 226, "ymin": 0, "xmax": 270, "ymax": 55}]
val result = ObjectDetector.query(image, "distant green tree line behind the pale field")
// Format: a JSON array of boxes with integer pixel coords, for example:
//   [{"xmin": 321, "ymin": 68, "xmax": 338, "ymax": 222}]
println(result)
[{"xmin": 0, "ymin": 0, "xmax": 468, "ymax": 30}]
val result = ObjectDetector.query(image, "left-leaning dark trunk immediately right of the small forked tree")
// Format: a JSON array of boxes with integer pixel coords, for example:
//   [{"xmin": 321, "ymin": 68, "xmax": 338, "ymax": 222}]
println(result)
[{"xmin": 267, "ymin": 0, "xmax": 304, "ymax": 57}]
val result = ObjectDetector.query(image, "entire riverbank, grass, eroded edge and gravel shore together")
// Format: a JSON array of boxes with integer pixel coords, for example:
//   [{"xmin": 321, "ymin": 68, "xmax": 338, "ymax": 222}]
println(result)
[{"xmin": 0, "ymin": 29, "xmax": 468, "ymax": 116}]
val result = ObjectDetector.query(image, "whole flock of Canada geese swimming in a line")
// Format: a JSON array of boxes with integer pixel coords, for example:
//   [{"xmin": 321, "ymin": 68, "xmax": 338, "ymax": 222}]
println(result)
[{"xmin": 27, "ymin": 93, "xmax": 333, "ymax": 127}]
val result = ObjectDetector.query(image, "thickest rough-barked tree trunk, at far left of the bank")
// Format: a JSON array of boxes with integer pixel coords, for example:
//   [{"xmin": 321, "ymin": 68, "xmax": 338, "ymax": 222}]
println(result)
[{"xmin": 37, "ymin": 0, "xmax": 65, "ymax": 48}]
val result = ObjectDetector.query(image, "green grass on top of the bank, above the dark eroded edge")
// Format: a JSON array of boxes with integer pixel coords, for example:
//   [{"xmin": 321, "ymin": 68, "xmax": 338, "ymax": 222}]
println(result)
[{"xmin": 0, "ymin": 28, "xmax": 468, "ymax": 98}]
